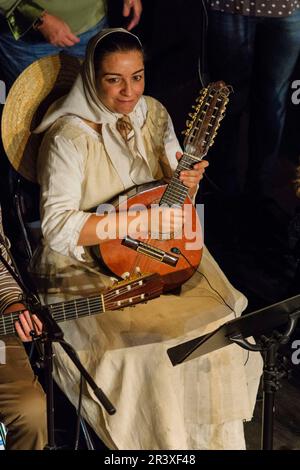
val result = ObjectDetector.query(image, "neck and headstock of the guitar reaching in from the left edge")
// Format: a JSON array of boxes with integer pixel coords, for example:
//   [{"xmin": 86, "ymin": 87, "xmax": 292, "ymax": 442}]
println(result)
[{"xmin": 0, "ymin": 274, "xmax": 163, "ymax": 336}]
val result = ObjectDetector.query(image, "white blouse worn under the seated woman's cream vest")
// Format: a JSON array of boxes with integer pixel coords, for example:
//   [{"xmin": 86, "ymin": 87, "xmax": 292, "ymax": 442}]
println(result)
[{"xmin": 38, "ymin": 116, "xmax": 182, "ymax": 261}]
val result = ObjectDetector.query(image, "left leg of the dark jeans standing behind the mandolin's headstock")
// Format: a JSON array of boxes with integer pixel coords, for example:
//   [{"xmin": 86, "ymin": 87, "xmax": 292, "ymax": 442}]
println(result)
[{"xmin": 208, "ymin": 11, "xmax": 256, "ymax": 194}]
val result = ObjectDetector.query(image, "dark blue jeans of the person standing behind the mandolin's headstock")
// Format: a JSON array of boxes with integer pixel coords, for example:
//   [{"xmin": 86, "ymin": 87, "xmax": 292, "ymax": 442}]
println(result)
[{"xmin": 208, "ymin": 11, "xmax": 300, "ymax": 196}]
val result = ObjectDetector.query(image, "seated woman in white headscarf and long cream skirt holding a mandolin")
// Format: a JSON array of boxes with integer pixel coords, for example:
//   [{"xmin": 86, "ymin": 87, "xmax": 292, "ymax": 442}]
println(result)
[{"xmin": 32, "ymin": 29, "xmax": 261, "ymax": 449}]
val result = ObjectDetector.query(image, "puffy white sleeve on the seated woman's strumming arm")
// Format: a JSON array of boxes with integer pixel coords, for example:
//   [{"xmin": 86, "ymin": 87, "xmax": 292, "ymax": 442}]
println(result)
[{"xmin": 37, "ymin": 135, "xmax": 91, "ymax": 259}]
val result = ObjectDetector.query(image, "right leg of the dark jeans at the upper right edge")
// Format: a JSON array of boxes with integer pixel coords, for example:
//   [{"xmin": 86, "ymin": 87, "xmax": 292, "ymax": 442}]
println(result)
[{"xmin": 248, "ymin": 11, "xmax": 300, "ymax": 194}]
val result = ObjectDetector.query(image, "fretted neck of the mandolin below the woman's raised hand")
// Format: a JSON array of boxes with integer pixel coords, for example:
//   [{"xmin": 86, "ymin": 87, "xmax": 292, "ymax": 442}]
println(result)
[{"xmin": 159, "ymin": 153, "xmax": 201, "ymax": 206}]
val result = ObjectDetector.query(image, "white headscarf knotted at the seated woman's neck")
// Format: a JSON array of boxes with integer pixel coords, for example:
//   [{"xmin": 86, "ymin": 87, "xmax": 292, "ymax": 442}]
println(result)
[{"xmin": 34, "ymin": 28, "xmax": 154, "ymax": 187}]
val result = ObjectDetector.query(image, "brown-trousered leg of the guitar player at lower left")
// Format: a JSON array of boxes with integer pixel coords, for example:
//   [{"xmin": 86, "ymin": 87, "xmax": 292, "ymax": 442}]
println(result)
[{"xmin": 0, "ymin": 337, "xmax": 47, "ymax": 450}]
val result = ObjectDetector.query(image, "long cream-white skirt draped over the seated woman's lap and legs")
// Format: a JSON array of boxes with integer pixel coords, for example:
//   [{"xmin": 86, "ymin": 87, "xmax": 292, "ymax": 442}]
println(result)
[{"xmin": 39, "ymin": 248, "xmax": 262, "ymax": 450}]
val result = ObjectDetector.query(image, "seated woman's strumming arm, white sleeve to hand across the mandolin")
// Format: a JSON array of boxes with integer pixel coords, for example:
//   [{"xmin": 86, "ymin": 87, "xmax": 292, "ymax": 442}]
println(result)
[{"xmin": 38, "ymin": 132, "xmax": 182, "ymax": 253}]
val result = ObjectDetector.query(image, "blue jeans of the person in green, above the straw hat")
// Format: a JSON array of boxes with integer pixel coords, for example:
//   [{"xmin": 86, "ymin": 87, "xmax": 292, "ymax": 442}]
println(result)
[{"xmin": 0, "ymin": 17, "xmax": 107, "ymax": 90}]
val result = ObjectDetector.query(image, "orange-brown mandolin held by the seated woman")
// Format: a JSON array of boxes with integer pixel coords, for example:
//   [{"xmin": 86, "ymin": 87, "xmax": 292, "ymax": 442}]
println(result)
[{"xmin": 99, "ymin": 81, "xmax": 231, "ymax": 292}]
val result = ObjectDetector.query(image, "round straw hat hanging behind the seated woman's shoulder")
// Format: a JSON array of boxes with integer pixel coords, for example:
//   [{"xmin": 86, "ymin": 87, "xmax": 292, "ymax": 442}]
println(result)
[{"xmin": 1, "ymin": 54, "xmax": 80, "ymax": 182}]
